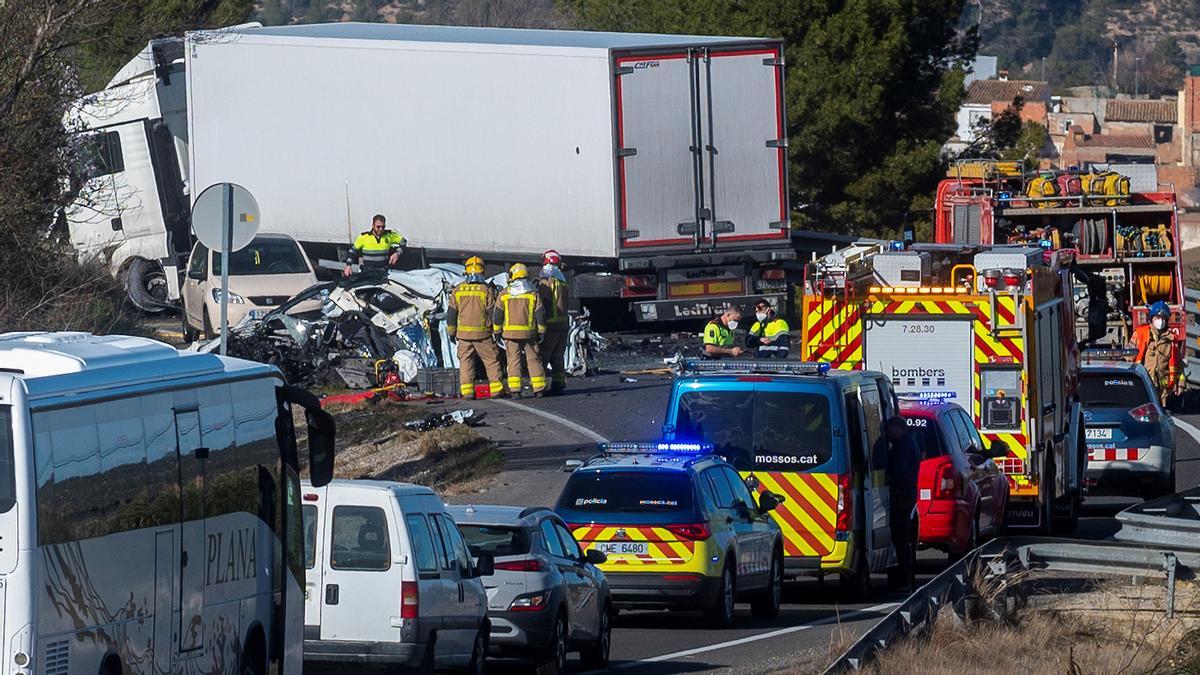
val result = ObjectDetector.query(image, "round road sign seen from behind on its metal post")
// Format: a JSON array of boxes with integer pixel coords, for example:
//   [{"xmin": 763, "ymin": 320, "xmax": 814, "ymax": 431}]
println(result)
[{"xmin": 192, "ymin": 183, "xmax": 260, "ymax": 354}]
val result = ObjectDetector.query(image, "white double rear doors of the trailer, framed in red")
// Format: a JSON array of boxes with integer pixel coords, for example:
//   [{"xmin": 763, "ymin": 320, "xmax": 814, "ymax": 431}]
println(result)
[{"xmin": 614, "ymin": 43, "xmax": 788, "ymax": 251}]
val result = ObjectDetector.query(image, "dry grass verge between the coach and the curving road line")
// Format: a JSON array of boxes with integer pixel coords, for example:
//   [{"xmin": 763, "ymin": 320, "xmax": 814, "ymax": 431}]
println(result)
[{"xmin": 304, "ymin": 400, "xmax": 503, "ymax": 495}]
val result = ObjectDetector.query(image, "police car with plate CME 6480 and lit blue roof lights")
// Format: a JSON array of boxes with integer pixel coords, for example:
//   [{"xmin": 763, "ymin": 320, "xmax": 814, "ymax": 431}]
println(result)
[{"xmin": 554, "ymin": 443, "xmax": 784, "ymax": 626}]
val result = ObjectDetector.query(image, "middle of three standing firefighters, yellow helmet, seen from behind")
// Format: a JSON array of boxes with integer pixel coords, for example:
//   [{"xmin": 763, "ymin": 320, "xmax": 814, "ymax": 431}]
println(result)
[{"xmin": 492, "ymin": 263, "xmax": 546, "ymax": 396}]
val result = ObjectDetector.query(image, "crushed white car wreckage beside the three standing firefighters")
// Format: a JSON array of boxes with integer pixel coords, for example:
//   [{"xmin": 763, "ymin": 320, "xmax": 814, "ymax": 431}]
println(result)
[{"xmin": 201, "ymin": 264, "xmax": 606, "ymax": 389}]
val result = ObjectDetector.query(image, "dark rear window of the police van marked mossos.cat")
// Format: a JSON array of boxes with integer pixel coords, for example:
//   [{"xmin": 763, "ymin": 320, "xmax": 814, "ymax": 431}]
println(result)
[{"xmin": 676, "ymin": 392, "xmax": 833, "ymax": 471}]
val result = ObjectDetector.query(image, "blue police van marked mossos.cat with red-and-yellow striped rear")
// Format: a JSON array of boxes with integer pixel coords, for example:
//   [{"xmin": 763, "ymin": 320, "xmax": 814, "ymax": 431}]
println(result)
[{"xmin": 664, "ymin": 359, "xmax": 914, "ymax": 598}]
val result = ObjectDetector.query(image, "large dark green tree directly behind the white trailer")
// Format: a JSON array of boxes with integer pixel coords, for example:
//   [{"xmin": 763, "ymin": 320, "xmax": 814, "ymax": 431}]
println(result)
[{"xmin": 560, "ymin": 0, "xmax": 976, "ymax": 233}]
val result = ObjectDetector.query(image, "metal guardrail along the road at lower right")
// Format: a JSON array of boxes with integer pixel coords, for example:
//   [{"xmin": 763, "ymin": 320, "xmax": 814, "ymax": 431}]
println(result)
[{"xmin": 826, "ymin": 488, "xmax": 1200, "ymax": 675}]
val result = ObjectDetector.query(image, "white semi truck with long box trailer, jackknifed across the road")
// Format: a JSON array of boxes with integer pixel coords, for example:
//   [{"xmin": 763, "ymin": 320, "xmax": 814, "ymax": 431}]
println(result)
[{"xmin": 66, "ymin": 23, "xmax": 797, "ymax": 321}]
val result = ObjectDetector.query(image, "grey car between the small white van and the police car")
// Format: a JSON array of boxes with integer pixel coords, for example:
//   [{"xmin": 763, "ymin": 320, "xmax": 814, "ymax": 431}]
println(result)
[{"xmin": 448, "ymin": 506, "xmax": 612, "ymax": 674}]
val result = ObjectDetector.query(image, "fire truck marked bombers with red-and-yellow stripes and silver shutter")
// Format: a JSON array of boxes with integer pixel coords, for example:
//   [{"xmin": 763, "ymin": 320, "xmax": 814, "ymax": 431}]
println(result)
[{"xmin": 797, "ymin": 243, "xmax": 1086, "ymax": 531}]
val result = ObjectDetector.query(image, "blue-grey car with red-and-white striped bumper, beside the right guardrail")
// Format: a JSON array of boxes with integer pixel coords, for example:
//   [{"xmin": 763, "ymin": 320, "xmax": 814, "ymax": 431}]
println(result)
[{"xmin": 1079, "ymin": 362, "xmax": 1175, "ymax": 498}]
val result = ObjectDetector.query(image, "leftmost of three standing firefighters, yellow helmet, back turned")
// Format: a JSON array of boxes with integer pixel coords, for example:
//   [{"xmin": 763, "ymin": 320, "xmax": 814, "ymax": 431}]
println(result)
[{"xmin": 446, "ymin": 256, "xmax": 504, "ymax": 399}]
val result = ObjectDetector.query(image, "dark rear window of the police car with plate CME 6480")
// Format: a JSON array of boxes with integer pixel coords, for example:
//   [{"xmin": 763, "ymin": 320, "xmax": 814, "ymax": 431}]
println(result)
[{"xmin": 557, "ymin": 471, "xmax": 695, "ymax": 521}]
